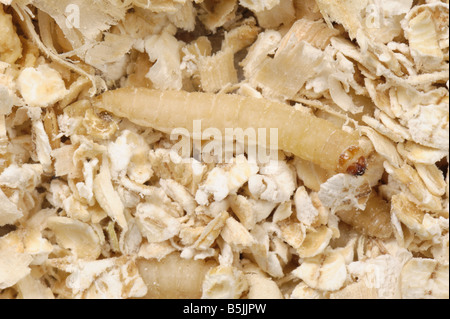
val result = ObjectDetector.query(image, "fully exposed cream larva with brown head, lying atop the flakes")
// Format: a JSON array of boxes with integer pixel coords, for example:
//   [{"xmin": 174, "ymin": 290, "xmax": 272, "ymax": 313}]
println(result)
[{"xmin": 94, "ymin": 88, "xmax": 367, "ymax": 175}]
